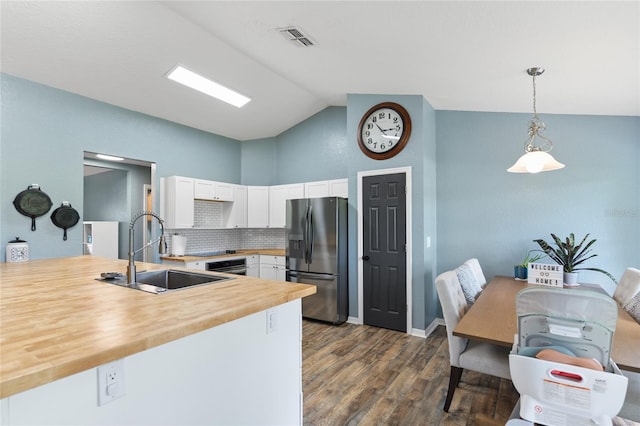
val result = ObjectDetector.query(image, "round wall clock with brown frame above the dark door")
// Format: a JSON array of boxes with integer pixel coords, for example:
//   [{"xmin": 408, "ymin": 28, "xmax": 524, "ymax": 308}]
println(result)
[{"xmin": 358, "ymin": 102, "xmax": 411, "ymax": 160}]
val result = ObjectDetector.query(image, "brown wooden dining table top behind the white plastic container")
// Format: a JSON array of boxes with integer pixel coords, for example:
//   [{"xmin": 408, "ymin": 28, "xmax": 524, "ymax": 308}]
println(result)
[{"xmin": 453, "ymin": 276, "xmax": 640, "ymax": 372}]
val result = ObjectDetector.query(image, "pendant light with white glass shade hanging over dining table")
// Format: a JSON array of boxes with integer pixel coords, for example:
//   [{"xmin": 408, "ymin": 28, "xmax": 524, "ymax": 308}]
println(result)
[{"xmin": 507, "ymin": 67, "xmax": 564, "ymax": 173}]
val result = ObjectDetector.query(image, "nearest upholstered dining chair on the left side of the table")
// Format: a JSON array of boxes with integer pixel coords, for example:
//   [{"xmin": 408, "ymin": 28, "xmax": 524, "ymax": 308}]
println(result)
[{"xmin": 436, "ymin": 271, "xmax": 511, "ymax": 412}]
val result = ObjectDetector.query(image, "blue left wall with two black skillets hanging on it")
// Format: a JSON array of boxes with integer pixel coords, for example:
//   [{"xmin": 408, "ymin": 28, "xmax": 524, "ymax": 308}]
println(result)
[{"xmin": 0, "ymin": 74, "xmax": 241, "ymax": 259}]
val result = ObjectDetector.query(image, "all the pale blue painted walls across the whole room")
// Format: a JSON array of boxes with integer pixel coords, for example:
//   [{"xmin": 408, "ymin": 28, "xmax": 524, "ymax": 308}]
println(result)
[{"xmin": 0, "ymin": 70, "xmax": 640, "ymax": 329}]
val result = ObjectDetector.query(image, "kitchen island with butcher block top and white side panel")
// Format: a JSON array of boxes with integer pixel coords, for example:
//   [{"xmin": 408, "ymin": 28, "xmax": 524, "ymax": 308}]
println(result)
[{"xmin": 0, "ymin": 256, "xmax": 315, "ymax": 424}]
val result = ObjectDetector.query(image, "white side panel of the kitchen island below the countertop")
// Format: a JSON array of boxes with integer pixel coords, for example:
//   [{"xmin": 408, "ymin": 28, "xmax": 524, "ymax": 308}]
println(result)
[{"xmin": 0, "ymin": 296, "xmax": 302, "ymax": 425}]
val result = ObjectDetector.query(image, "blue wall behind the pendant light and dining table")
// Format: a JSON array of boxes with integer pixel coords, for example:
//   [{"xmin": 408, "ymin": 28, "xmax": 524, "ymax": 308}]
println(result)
[{"xmin": 436, "ymin": 111, "xmax": 640, "ymax": 296}]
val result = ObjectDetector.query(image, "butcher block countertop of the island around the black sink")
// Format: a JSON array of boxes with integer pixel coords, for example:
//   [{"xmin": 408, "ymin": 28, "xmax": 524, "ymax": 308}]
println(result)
[{"xmin": 0, "ymin": 256, "xmax": 316, "ymax": 398}]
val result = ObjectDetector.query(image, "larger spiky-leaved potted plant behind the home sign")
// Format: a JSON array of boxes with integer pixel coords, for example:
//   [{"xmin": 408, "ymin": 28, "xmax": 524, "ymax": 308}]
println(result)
[{"xmin": 533, "ymin": 233, "xmax": 617, "ymax": 285}]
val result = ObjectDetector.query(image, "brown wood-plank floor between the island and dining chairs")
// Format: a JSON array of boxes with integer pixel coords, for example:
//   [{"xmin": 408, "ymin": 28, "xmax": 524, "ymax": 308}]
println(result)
[{"xmin": 302, "ymin": 320, "xmax": 518, "ymax": 426}]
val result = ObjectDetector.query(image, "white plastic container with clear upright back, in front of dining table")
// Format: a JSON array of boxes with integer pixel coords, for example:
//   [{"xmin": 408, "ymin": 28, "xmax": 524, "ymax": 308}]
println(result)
[{"xmin": 507, "ymin": 287, "xmax": 627, "ymax": 426}]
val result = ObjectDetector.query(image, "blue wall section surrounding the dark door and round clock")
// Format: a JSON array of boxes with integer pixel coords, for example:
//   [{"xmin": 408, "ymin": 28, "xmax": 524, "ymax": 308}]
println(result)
[{"xmin": 346, "ymin": 94, "xmax": 437, "ymax": 329}]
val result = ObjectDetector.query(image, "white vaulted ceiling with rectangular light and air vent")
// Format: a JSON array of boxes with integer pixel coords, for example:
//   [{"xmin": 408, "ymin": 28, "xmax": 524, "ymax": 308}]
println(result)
[{"xmin": 0, "ymin": 0, "xmax": 640, "ymax": 140}]
